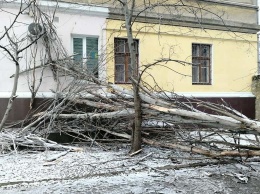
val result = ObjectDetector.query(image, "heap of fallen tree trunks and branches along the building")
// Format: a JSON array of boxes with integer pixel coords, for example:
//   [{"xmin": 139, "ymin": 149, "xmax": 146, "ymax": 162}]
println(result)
[{"xmin": 4, "ymin": 64, "xmax": 260, "ymax": 158}]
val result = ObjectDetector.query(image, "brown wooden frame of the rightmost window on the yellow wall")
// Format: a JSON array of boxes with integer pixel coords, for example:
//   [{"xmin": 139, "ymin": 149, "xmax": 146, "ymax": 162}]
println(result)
[{"xmin": 191, "ymin": 43, "xmax": 212, "ymax": 85}]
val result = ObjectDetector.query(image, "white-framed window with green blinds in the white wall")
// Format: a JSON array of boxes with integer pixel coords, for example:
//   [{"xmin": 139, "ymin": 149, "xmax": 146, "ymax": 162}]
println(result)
[{"xmin": 73, "ymin": 37, "xmax": 98, "ymax": 77}]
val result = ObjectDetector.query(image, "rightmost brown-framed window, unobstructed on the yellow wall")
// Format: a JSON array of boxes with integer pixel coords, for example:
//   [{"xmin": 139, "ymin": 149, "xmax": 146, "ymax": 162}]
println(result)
[{"xmin": 192, "ymin": 44, "xmax": 211, "ymax": 84}]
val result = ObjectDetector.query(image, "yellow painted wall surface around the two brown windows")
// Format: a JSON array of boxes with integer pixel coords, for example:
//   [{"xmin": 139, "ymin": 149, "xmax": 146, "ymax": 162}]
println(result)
[{"xmin": 106, "ymin": 20, "xmax": 257, "ymax": 92}]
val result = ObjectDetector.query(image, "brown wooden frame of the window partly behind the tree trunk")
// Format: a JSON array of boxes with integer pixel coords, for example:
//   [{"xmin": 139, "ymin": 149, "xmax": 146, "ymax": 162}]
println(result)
[{"xmin": 114, "ymin": 37, "xmax": 139, "ymax": 84}]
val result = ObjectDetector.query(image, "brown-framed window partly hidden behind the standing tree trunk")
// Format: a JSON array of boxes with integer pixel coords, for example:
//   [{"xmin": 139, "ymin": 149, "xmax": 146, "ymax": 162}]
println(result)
[{"xmin": 114, "ymin": 38, "xmax": 139, "ymax": 83}]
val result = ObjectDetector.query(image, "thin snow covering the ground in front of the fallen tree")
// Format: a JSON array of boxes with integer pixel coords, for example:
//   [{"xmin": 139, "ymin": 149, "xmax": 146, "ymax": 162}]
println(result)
[{"xmin": 0, "ymin": 145, "xmax": 260, "ymax": 194}]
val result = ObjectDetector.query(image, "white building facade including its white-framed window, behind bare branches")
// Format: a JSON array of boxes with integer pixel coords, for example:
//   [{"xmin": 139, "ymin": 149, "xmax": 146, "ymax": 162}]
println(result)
[{"xmin": 0, "ymin": 1, "xmax": 108, "ymax": 121}]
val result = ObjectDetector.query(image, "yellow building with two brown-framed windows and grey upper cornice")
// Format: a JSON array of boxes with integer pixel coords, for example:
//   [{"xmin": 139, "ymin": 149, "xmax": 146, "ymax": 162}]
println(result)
[{"xmin": 106, "ymin": 0, "xmax": 260, "ymax": 117}]
